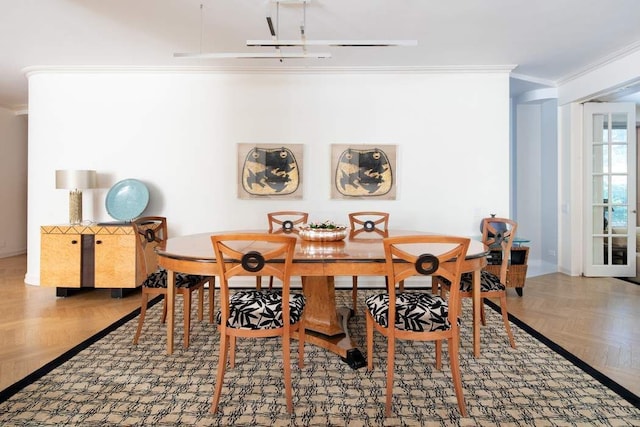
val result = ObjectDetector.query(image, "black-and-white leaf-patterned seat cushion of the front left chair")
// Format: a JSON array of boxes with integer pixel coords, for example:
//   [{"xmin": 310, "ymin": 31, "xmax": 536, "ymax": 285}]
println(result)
[{"xmin": 216, "ymin": 290, "xmax": 305, "ymax": 329}]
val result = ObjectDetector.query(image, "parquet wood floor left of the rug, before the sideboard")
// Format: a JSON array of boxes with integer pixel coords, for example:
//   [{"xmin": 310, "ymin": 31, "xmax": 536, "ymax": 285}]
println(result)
[{"xmin": 0, "ymin": 255, "xmax": 140, "ymax": 390}]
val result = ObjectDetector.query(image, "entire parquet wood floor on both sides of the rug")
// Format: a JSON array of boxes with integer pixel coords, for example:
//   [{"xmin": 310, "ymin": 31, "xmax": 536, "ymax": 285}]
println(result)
[{"xmin": 0, "ymin": 255, "xmax": 640, "ymax": 395}]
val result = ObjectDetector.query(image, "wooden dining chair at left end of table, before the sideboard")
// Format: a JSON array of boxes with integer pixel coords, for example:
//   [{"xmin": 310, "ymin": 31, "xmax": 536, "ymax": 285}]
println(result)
[{"xmin": 131, "ymin": 216, "xmax": 215, "ymax": 348}]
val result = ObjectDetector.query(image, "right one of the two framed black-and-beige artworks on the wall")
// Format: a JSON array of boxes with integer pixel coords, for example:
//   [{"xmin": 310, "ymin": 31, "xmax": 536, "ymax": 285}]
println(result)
[{"xmin": 331, "ymin": 144, "xmax": 396, "ymax": 200}]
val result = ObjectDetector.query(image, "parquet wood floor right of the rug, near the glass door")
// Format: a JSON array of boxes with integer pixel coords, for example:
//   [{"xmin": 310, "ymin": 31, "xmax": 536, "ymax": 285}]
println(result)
[{"xmin": 500, "ymin": 273, "xmax": 640, "ymax": 396}]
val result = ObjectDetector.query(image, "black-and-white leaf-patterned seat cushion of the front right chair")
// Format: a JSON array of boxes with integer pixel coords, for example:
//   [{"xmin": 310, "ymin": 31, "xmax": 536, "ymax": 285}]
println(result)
[{"xmin": 365, "ymin": 292, "xmax": 451, "ymax": 332}]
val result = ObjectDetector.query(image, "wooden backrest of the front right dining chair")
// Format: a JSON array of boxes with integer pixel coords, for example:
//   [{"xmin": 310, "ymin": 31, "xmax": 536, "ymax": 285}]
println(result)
[{"xmin": 382, "ymin": 235, "xmax": 470, "ymax": 328}]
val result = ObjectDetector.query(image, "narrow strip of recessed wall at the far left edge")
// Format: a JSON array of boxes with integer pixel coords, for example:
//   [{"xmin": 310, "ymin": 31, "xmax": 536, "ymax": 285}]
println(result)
[{"xmin": 0, "ymin": 107, "xmax": 27, "ymax": 258}]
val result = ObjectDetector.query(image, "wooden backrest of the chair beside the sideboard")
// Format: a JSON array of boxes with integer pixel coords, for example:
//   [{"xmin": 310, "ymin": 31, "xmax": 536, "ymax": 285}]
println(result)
[{"xmin": 131, "ymin": 216, "xmax": 168, "ymax": 283}]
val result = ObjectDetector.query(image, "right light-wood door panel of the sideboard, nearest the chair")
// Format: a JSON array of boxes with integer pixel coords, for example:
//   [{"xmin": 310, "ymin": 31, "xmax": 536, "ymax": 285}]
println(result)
[{"xmin": 95, "ymin": 234, "xmax": 136, "ymax": 288}]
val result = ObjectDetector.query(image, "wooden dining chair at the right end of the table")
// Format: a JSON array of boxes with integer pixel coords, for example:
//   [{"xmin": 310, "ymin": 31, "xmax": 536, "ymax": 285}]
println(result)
[{"xmin": 433, "ymin": 217, "xmax": 518, "ymax": 348}]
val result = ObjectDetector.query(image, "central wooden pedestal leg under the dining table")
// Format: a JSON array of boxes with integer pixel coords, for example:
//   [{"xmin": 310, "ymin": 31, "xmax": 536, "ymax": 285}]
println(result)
[{"xmin": 302, "ymin": 276, "xmax": 366, "ymax": 369}]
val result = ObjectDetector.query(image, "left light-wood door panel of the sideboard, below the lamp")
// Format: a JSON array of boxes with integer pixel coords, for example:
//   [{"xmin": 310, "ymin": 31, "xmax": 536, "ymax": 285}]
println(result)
[{"xmin": 40, "ymin": 234, "xmax": 82, "ymax": 288}]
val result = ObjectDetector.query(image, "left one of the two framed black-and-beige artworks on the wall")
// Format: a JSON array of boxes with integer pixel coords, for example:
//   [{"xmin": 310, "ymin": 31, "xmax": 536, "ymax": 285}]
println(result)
[{"xmin": 238, "ymin": 143, "xmax": 303, "ymax": 199}]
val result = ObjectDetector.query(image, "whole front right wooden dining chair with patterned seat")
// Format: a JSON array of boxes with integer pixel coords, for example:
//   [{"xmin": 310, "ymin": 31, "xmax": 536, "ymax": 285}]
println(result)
[{"xmin": 365, "ymin": 235, "xmax": 470, "ymax": 416}]
